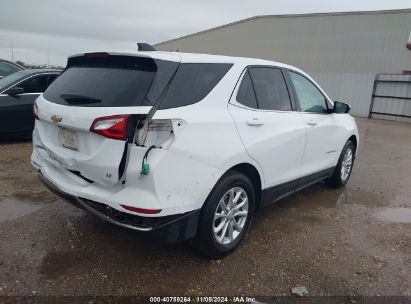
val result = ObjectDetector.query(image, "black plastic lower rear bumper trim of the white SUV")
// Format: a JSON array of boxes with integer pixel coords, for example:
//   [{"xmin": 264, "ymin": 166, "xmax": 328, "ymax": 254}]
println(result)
[{"xmin": 38, "ymin": 171, "xmax": 200, "ymax": 243}]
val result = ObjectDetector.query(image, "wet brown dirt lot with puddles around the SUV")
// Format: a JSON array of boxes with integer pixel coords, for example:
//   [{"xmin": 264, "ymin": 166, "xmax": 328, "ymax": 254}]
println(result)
[{"xmin": 0, "ymin": 119, "xmax": 411, "ymax": 296}]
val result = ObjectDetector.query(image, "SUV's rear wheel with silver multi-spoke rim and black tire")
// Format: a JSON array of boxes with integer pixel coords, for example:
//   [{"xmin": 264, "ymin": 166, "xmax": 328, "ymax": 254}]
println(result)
[{"xmin": 192, "ymin": 171, "xmax": 255, "ymax": 259}]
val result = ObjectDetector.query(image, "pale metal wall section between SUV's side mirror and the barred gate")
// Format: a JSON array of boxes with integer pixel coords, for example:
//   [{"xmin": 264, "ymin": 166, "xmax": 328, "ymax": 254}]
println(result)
[{"xmin": 310, "ymin": 73, "xmax": 375, "ymax": 117}]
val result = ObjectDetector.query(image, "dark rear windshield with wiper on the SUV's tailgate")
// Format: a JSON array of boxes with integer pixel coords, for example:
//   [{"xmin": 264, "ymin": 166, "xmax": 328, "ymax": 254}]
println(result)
[{"xmin": 44, "ymin": 58, "xmax": 157, "ymax": 107}]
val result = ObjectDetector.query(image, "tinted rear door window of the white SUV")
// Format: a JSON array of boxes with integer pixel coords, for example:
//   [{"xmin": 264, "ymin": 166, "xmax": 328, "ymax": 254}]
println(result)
[{"xmin": 249, "ymin": 67, "xmax": 292, "ymax": 111}]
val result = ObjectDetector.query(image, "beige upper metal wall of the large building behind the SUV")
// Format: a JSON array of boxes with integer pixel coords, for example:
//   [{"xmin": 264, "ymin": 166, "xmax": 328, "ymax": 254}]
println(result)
[{"xmin": 156, "ymin": 10, "xmax": 411, "ymax": 74}]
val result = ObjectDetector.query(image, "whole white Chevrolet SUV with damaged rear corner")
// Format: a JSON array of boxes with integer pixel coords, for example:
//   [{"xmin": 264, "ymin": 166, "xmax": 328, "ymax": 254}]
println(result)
[{"xmin": 31, "ymin": 51, "xmax": 358, "ymax": 258}]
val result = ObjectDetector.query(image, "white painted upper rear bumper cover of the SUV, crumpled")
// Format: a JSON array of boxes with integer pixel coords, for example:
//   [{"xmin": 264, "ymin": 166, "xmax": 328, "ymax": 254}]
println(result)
[{"xmin": 31, "ymin": 126, "xmax": 224, "ymax": 217}]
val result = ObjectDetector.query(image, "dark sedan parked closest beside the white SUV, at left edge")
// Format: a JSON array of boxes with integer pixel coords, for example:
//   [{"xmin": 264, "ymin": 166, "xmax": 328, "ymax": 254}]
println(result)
[{"xmin": 0, "ymin": 69, "xmax": 61, "ymax": 139}]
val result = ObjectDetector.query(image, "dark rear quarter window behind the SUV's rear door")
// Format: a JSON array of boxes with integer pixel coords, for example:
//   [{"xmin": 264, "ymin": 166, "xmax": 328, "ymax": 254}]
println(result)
[{"xmin": 159, "ymin": 63, "xmax": 232, "ymax": 109}]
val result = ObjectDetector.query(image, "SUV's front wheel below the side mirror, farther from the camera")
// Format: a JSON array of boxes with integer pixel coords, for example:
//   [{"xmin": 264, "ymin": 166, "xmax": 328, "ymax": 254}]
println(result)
[{"xmin": 325, "ymin": 140, "xmax": 355, "ymax": 188}]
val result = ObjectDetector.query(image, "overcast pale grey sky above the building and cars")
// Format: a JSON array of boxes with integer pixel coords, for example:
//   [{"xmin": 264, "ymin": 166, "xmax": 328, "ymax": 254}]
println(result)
[{"xmin": 0, "ymin": 0, "xmax": 411, "ymax": 66}]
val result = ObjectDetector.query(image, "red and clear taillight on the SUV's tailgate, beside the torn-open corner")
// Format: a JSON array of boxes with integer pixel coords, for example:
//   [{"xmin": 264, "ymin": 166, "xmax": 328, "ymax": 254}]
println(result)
[{"xmin": 90, "ymin": 115, "xmax": 130, "ymax": 140}]
